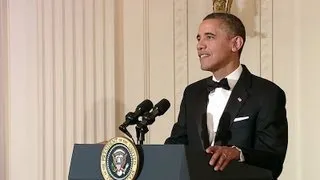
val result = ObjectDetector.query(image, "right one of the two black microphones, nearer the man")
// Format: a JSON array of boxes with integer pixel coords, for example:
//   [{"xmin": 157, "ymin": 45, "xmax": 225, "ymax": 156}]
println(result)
[{"xmin": 137, "ymin": 99, "xmax": 170, "ymax": 128}]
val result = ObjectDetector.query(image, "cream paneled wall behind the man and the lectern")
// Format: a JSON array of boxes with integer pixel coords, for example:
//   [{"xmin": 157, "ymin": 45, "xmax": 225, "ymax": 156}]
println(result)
[{"xmin": 0, "ymin": 0, "xmax": 320, "ymax": 180}]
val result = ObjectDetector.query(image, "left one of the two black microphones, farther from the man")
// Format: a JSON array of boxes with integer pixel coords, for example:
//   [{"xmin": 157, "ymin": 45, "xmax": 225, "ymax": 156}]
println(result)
[{"xmin": 119, "ymin": 99, "xmax": 153, "ymax": 138}]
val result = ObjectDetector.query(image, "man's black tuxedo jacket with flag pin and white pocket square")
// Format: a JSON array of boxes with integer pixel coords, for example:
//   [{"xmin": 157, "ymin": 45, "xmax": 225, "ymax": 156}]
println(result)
[{"xmin": 165, "ymin": 65, "xmax": 288, "ymax": 178}]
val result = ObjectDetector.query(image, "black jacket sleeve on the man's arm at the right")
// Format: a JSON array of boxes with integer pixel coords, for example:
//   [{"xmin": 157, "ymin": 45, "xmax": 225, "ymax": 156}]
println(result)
[{"xmin": 239, "ymin": 88, "xmax": 288, "ymax": 178}]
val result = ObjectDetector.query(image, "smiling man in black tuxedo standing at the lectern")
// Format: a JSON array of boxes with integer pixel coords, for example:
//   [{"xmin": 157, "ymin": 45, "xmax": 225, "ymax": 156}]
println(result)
[{"xmin": 165, "ymin": 13, "xmax": 288, "ymax": 178}]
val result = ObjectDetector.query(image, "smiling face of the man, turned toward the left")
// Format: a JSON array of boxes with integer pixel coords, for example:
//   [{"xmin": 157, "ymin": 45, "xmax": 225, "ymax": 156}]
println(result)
[{"xmin": 197, "ymin": 19, "xmax": 232, "ymax": 72}]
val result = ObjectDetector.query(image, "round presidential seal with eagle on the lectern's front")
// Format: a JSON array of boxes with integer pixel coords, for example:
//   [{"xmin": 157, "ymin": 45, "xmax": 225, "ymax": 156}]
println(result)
[{"xmin": 100, "ymin": 137, "xmax": 139, "ymax": 180}]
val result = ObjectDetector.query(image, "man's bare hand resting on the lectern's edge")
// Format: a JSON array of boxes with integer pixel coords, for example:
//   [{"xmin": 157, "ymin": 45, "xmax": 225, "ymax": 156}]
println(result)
[{"xmin": 206, "ymin": 146, "xmax": 240, "ymax": 171}]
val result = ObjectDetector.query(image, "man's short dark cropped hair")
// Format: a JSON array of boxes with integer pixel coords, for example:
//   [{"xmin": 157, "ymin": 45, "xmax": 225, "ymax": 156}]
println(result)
[{"xmin": 203, "ymin": 13, "xmax": 246, "ymax": 55}]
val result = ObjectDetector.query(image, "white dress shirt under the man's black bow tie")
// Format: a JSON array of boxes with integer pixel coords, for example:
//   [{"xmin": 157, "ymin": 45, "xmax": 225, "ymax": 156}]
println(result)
[{"xmin": 207, "ymin": 65, "xmax": 242, "ymax": 146}]
